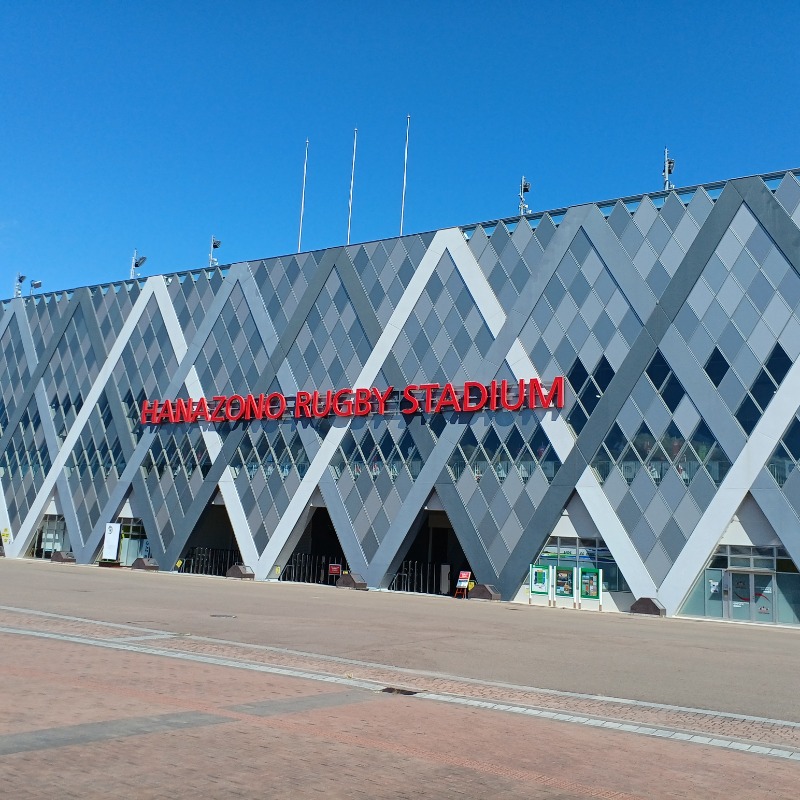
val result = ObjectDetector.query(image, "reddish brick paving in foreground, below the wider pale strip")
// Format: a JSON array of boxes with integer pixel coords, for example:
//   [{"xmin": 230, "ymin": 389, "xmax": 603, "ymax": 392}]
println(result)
[{"xmin": 0, "ymin": 634, "xmax": 800, "ymax": 800}]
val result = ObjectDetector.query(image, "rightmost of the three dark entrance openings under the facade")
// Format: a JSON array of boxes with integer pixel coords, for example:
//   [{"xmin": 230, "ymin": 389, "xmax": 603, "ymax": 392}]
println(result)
[{"xmin": 389, "ymin": 511, "xmax": 472, "ymax": 595}]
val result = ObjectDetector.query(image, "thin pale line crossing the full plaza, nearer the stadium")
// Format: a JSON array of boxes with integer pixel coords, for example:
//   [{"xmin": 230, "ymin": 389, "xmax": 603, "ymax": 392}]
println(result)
[{"xmin": 0, "ymin": 605, "xmax": 800, "ymax": 728}]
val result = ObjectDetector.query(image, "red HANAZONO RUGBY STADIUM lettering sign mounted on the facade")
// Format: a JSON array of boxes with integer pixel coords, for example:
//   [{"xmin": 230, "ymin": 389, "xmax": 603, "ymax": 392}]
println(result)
[{"xmin": 141, "ymin": 375, "xmax": 564, "ymax": 425}]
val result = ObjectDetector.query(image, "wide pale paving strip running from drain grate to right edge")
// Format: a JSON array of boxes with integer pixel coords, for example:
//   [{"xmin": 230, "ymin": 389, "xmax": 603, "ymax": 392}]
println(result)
[{"xmin": 415, "ymin": 692, "xmax": 800, "ymax": 761}]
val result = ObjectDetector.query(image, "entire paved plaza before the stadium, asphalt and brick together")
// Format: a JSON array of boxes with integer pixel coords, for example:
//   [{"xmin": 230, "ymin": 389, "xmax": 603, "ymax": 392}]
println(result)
[{"xmin": 0, "ymin": 559, "xmax": 800, "ymax": 800}]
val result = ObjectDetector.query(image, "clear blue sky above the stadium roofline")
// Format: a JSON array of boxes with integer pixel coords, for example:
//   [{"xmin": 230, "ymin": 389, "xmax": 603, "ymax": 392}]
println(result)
[{"xmin": 0, "ymin": 0, "xmax": 800, "ymax": 297}]
